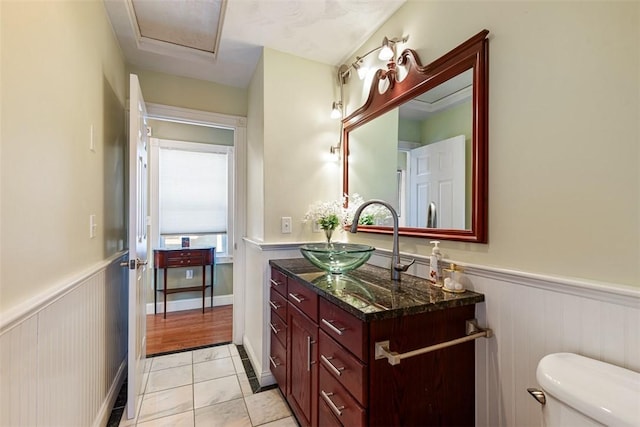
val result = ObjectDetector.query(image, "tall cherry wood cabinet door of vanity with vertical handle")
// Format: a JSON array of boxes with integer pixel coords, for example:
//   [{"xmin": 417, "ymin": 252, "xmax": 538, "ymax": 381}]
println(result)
[{"xmin": 287, "ymin": 303, "xmax": 318, "ymax": 426}]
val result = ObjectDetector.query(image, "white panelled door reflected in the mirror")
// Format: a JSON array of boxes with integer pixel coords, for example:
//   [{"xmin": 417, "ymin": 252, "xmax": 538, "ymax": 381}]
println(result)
[{"xmin": 407, "ymin": 135, "xmax": 466, "ymax": 229}]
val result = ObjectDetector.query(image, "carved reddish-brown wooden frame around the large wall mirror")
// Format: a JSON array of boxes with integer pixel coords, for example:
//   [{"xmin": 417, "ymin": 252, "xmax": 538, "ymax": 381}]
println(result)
[{"xmin": 342, "ymin": 30, "xmax": 489, "ymax": 243}]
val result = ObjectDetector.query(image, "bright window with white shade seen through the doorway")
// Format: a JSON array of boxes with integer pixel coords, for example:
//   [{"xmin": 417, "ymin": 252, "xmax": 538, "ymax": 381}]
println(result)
[{"xmin": 158, "ymin": 140, "xmax": 233, "ymax": 257}]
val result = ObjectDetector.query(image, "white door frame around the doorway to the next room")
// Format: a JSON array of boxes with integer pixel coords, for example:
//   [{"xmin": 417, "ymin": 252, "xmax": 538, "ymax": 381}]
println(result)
[{"xmin": 146, "ymin": 102, "xmax": 247, "ymax": 345}]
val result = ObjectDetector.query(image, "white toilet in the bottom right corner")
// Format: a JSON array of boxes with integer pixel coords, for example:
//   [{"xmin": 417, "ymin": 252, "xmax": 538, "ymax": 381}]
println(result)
[{"xmin": 528, "ymin": 353, "xmax": 640, "ymax": 427}]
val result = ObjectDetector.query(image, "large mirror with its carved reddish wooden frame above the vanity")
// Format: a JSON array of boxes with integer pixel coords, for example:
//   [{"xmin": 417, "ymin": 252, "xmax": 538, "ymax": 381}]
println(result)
[{"xmin": 342, "ymin": 30, "xmax": 489, "ymax": 243}]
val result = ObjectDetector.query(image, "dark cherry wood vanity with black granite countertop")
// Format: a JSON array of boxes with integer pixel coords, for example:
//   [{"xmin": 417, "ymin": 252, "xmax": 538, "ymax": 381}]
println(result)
[{"xmin": 269, "ymin": 258, "xmax": 484, "ymax": 427}]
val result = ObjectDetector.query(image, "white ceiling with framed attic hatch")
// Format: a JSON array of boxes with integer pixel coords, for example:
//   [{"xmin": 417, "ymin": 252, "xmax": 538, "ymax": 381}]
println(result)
[{"xmin": 104, "ymin": 0, "xmax": 405, "ymax": 87}]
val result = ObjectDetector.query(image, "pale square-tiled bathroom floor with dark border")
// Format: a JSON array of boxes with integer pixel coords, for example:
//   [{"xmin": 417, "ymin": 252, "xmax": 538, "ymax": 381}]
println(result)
[{"xmin": 112, "ymin": 344, "xmax": 298, "ymax": 427}]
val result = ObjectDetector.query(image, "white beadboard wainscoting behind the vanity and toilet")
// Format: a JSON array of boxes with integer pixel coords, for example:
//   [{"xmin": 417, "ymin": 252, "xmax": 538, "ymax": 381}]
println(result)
[{"xmin": 245, "ymin": 240, "xmax": 640, "ymax": 427}]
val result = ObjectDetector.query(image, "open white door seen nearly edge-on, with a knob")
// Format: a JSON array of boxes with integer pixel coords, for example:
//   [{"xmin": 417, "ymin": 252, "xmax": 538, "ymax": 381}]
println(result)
[{"xmin": 127, "ymin": 74, "xmax": 149, "ymax": 419}]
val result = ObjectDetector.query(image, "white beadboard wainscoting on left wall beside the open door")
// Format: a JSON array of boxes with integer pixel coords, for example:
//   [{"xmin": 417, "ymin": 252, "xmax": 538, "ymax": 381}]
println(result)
[{"xmin": 0, "ymin": 254, "xmax": 128, "ymax": 427}]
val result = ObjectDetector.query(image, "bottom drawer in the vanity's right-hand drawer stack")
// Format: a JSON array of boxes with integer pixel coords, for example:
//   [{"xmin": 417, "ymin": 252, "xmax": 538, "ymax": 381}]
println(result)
[{"xmin": 318, "ymin": 366, "xmax": 366, "ymax": 427}]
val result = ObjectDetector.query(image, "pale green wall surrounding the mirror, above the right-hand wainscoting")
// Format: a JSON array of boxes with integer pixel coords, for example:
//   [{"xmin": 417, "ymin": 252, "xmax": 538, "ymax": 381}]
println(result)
[{"xmin": 346, "ymin": 0, "xmax": 640, "ymax": 287}]
